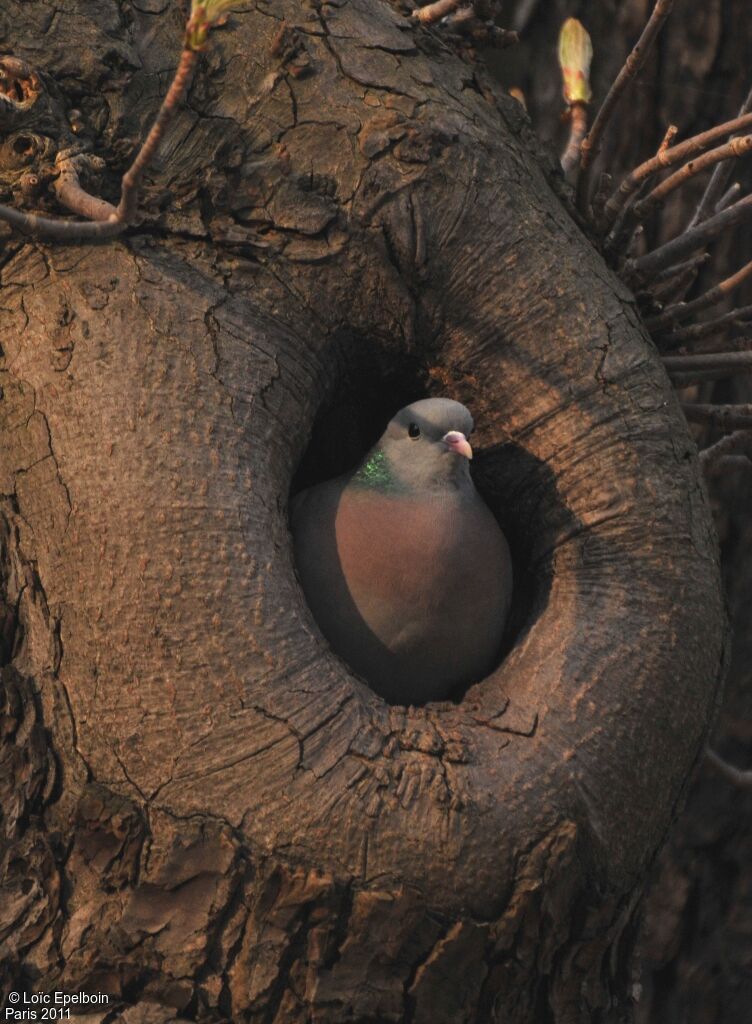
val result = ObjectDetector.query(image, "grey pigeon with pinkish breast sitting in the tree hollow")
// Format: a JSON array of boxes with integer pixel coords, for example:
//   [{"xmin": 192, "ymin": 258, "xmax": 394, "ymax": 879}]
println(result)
[{"xmin": 292, "ymin": 398, "xmax": 512, "ymax": 705}]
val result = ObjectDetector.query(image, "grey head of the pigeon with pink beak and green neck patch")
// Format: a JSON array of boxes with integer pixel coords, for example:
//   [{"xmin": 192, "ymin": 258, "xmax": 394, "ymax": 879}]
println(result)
[{"xmin": 356, "ymin": 398, "xmax": 472, "ymax": 490}]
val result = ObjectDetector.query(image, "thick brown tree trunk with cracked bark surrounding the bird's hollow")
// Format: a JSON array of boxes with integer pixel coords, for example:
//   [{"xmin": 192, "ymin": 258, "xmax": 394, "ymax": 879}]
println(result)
[{"xmin": 0, "ymin": 0, "xmax": 724, "ymax": 1024}]
